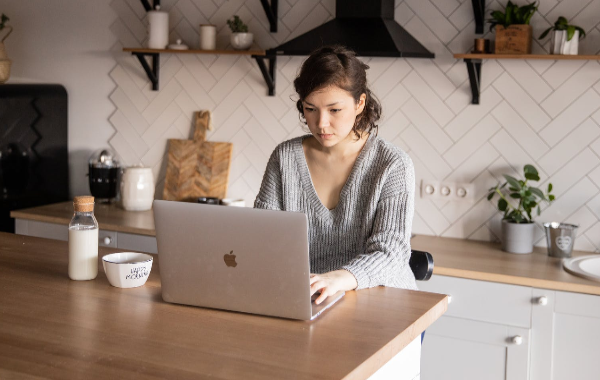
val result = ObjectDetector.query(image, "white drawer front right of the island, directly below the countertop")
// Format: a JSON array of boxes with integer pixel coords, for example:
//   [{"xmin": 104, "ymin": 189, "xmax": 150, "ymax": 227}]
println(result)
[{"xmin": 418, "ymin": 275, "xmax": 532, "ymax": 328}]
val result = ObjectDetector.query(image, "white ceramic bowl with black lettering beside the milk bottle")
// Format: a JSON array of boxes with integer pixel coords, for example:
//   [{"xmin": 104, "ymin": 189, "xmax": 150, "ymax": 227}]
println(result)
[{"xmin": 102, "ymin": 252, "xmax": 153, "ymax": 288}]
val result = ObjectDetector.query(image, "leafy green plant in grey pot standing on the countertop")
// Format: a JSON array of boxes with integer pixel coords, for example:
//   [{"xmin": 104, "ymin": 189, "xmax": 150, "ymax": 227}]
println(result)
[{"xmin": 488, "ymin": 165, "xmax": 554, "ymax": 253}]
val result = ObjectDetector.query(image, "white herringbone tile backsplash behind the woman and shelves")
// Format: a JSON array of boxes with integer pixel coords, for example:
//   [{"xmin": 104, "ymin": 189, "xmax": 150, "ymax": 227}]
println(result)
[{"xmin": 109, "ymin": 0, "xmax": 600, "ymax": 251}]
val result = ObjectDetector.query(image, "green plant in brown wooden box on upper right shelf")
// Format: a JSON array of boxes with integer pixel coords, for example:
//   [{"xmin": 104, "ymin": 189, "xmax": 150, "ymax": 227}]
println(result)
[{"xmin": 488, "ymin": 0, "xmax": 538, "ymax": 54}]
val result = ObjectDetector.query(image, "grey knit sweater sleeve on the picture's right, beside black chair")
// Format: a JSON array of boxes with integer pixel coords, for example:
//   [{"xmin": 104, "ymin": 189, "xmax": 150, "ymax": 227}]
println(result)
[{"xmin": 343, "ymin": 156, "xmax": 415, "ymax": 289}]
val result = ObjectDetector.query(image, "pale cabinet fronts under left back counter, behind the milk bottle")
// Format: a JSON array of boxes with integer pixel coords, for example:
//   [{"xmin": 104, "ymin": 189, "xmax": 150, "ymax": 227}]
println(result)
[{"xmin": 15, "ymin": 219, "xmax": 158, "ymax": 253}]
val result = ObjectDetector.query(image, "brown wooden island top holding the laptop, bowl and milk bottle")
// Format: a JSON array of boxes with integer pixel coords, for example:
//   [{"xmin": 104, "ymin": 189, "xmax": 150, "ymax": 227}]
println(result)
[{"xmin": 0, "ymin": 233, "xmax": 447, "ymax": 379}]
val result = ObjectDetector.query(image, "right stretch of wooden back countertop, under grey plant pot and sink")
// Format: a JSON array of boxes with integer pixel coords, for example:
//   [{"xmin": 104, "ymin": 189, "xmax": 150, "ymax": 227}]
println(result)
[{"xmin": 411, "ymin": 235, "xmax": 600, "ymax": 295}]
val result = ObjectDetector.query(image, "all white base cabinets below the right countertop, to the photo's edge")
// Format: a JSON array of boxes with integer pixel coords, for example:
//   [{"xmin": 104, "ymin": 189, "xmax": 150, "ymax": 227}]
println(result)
[{"xmin": 419, "ymin": 276, "xmax": 600, "ymax": 380}]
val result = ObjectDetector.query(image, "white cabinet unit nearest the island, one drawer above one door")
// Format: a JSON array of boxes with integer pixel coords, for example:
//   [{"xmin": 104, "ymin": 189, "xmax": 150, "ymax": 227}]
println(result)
[{"xmin": 419, "ymin": 276, "xmax": 532, "ymax": 380}]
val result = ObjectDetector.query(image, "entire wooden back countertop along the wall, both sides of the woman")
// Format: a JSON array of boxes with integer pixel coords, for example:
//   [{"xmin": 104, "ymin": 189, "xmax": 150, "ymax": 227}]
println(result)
[{"xmin": 11, "ymin": 202, "xmax": 600, "ymax": 295}]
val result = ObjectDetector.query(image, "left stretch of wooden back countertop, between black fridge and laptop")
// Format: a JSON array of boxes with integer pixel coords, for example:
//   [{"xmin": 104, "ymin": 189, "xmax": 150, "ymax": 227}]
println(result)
[{"xmin": 10, "ymin": 202, "xmax": 156, "ymax": 236}]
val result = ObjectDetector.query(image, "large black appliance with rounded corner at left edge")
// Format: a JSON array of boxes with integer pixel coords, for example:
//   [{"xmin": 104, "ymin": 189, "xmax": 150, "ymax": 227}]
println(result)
[{"xmin": 0, "ymin": 84, "xmax": 69, "ymax": 232}]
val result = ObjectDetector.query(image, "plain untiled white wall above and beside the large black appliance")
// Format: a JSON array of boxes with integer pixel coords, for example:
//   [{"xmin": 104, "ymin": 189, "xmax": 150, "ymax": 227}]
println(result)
[{"xmin": 0, "ymin": 0, "xmax": 116, "ymax": 195}]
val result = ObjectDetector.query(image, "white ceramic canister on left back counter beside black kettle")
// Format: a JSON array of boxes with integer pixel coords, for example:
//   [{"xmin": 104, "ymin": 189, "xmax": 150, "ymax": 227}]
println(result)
[{"xmin": 121, "ymin": 167, "xmax": 154, "ymax": 211}]
